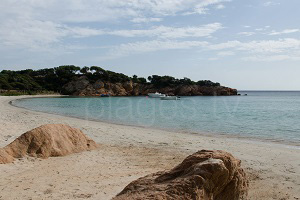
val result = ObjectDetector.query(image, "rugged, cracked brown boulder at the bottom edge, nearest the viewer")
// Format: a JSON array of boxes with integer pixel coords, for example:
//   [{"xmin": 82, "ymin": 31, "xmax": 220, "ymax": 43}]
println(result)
[{"xmin": 114, "ymin": 150, "xmax": 248, "ymax": 200}]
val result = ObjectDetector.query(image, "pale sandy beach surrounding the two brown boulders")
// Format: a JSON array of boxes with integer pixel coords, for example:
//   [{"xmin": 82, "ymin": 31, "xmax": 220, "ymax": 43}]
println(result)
[{"xmin": 0, "ymin": 96, "xmax": 300, "ymax": 200}]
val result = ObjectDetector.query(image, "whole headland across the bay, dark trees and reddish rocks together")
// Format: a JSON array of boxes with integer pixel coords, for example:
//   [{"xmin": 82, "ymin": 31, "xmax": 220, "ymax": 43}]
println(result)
[{"xmin": 0, "ymin": 65, "xmax": 237, "ymax": 96}]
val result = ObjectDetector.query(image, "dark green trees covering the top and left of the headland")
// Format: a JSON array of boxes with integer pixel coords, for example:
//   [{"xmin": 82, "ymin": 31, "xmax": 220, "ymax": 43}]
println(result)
[{"xmin": 0, "ymin": 65, "xmax": 220, "ymax": 92}]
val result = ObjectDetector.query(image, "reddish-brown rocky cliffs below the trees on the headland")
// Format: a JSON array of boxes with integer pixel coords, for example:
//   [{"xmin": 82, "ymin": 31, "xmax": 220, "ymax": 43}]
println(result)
[{"xmin": 62, "ymin": 76, "xmax": 237, "ymax": 96}]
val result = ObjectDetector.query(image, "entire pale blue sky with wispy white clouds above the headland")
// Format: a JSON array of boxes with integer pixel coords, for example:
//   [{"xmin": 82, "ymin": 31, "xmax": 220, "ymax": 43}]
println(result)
[{"xmin": 0, "ymin": 0, "xmax": 300, "ymax": 90}]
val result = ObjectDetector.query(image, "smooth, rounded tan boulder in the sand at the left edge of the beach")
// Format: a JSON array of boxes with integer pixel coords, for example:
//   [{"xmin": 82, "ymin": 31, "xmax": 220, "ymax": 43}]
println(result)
[{"xmin": 0, "ymin": 124, "xmax": 97, "ymax": 164}]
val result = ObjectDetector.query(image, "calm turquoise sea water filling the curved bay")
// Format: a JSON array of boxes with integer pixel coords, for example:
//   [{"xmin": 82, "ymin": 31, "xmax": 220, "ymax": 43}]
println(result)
[{"xmin": 14, "ymin": 91, "xmax": 300, "ymax": 146}]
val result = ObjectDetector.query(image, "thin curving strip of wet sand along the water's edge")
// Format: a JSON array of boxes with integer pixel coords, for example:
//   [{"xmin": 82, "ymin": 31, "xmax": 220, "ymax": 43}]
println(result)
[{"xmin": 9, "ymin": 95, "xmax": 300, "ymax": 150}]
